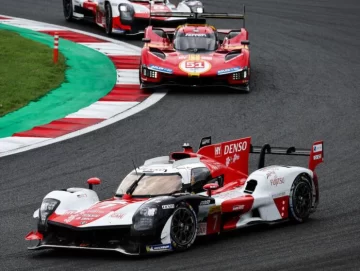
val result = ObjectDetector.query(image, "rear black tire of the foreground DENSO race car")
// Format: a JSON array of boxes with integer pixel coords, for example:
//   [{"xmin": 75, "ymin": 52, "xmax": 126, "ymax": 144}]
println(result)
[{"xmin": 289, "ymin": 175, "xmax": 313, "ymax": 223}]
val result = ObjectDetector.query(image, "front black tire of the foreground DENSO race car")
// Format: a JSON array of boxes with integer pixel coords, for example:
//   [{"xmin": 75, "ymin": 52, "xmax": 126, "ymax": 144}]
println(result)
[{"xmin": 170, "ymin": 203, "xmax": 197, "ymax": 251}]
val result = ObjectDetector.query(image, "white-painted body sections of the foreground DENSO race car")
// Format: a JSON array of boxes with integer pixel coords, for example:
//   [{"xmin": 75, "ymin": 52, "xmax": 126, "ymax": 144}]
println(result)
[{"xmin": 34, "ymin": 160, "xmax": 315, "ymax": 235}]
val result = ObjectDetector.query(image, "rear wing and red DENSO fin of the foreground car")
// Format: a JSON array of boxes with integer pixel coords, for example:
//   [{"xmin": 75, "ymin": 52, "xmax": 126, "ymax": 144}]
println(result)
[{"xmin": 197, "ymin": 136, "xmax": 324, "ymax": 174}]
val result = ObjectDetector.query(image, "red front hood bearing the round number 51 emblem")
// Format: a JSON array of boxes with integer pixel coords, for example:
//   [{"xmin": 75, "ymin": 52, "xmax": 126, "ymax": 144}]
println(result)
[{"xmin": 145, "ymin": 51, "xmax": 247, "ymax": 76}]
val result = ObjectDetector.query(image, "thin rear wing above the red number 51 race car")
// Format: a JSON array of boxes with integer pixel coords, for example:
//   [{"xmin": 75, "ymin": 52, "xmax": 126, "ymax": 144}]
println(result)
[{"xmin": 149, "ymin": 4, "xmax": 245, "ymax": 28}]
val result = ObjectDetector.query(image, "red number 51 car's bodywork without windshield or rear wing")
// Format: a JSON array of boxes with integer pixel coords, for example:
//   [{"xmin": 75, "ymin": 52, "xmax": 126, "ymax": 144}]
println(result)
[{"xmin": 140, "ymin": 13, "xmax": 251, "ymax": 91}]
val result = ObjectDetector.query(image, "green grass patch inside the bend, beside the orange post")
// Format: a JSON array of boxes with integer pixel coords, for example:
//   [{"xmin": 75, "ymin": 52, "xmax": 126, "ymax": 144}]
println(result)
[{"xmin": 0, "ymin": 30, "xmax": 66, "ymax": 117}]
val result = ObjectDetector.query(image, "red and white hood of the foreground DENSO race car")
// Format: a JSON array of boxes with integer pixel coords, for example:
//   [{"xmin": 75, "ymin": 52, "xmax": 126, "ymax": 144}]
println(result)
[{"xmin": 48, "ymin": 199, "xmax": 147, "ymax": 228}]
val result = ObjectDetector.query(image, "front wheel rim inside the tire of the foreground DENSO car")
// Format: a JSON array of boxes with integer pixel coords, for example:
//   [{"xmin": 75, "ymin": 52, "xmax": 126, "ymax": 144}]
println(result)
[{"xmin": 171, "ymin": 208, "xmax": 196, "ymax": 245}]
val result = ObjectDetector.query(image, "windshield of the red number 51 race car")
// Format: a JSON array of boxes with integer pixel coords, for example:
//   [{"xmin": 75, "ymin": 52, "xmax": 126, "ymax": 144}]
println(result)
[{"xmin": 174, "ymin": 32, "xmax": 216, "ymax": 52}]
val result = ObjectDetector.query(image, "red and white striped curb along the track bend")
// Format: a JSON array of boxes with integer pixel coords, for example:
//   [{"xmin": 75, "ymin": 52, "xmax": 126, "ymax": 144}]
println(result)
[{"xmin": 0, "ymin": 15, "xmax": 166, "ymax": 157}]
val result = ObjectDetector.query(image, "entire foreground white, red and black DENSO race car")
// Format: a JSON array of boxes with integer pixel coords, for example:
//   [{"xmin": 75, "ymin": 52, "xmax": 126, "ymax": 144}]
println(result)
[{"xmin": 26, "ymin": 137, "xmax": 324, "ymax": 255}]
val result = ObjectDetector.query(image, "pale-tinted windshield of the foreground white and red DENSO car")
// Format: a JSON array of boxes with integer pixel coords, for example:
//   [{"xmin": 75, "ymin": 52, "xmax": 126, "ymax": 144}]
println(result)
[{"xmin": 116, "ymin": 173, "xmax": 182, "ymax": 196}]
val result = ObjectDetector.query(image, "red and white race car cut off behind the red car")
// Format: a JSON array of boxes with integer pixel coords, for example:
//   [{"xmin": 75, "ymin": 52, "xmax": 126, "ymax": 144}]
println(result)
[{"xmin": 63, "ymin": 0, "xmax": 204, "ymax": 35}]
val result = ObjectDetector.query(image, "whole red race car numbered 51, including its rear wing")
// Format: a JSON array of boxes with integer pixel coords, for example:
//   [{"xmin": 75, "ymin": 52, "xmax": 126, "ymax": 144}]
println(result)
[{"xmin": 139, "ymin": 8, "xmax": 250, "ymax": 92}]
